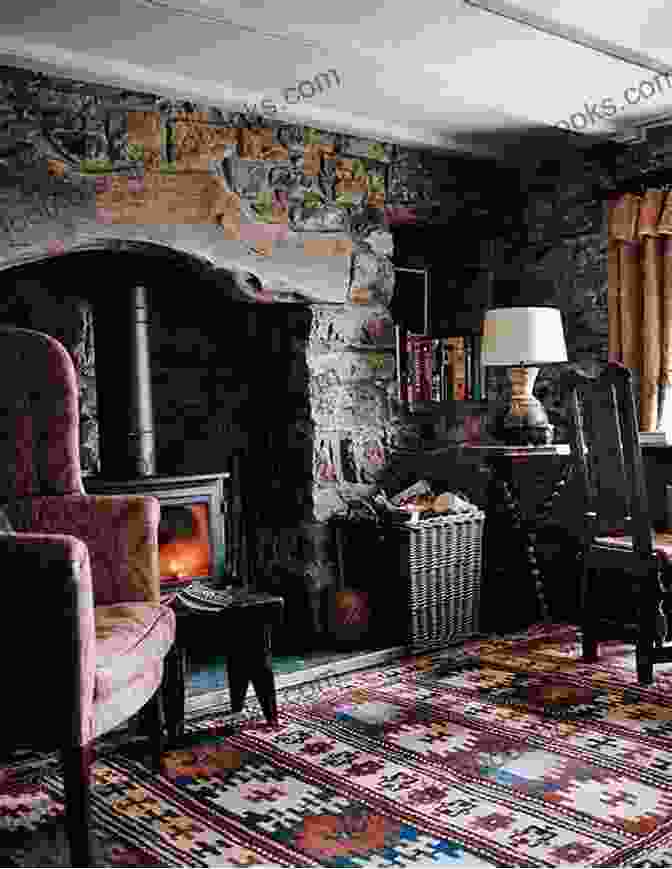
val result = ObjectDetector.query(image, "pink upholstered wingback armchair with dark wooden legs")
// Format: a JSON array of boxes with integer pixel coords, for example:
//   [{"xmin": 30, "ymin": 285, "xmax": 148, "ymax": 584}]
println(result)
[{"xmin": 0, "ymin": 326, "xmax": 175, "ymax": 866}]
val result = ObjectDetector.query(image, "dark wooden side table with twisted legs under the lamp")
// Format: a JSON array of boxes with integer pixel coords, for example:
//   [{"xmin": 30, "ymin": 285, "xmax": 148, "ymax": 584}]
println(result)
[{"xmin": 461, "ymin": 444, "xmax": 572, "ymax": 630}]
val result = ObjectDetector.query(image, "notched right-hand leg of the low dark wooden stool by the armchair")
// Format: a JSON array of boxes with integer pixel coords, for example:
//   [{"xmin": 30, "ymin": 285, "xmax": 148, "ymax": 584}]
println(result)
[{"xmin": 226, "ymin": 624, "xmax": 278, "ymax": 724}]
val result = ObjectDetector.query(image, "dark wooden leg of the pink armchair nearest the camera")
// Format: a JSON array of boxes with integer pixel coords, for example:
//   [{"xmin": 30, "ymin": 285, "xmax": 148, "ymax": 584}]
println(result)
[{"xmin": 61, "ymin": 744, "xmax": 93, "ymax": 866}]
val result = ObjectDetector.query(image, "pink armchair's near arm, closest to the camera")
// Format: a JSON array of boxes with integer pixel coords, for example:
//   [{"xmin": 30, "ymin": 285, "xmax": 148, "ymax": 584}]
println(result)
[{"xmin": 0, "ymin": 534, "xmax": 96, "ymax": 748}]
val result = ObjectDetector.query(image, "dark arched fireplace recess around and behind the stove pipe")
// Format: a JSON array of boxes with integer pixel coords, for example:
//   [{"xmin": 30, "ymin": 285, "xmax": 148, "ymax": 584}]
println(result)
[{"xmin": 0, "ymin": 240, "xmax": 313, "ymax": 592}]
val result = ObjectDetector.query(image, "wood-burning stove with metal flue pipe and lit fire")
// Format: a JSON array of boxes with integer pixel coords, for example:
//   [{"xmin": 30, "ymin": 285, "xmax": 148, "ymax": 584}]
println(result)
[{"xmin": 85, "ymin": 286, "xmax": 235, "ymax": 587}]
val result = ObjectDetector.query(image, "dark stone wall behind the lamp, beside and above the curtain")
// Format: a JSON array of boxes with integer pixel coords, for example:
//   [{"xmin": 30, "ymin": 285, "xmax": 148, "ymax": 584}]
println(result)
[{"xmin": 497, "ymin": 137, "xmax": 672, "ymax": 439}]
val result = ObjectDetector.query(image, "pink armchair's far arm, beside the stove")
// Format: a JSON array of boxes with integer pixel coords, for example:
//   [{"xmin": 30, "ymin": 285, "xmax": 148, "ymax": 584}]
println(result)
[{"xmin": 7, "ymin": 495, "xmax": 161, "ymax": 605}]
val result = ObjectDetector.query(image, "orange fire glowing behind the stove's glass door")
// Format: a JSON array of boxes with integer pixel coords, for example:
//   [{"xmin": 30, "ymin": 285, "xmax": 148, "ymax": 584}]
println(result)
[{"xmin": 159, "ymin": 504, "xmax": 212, "ymax": 579}]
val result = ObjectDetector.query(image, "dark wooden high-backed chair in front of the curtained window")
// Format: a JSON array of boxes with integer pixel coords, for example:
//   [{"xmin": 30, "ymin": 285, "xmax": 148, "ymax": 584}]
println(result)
[{"xmin": 562, "ymin": 363, "xmax": 672, "ymax": 685}]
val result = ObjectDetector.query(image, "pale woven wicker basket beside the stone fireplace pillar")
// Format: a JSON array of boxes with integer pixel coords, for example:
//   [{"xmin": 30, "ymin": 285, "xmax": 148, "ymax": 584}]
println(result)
[{"xmin": 386, "ymin": 508, "xmax": 485, "ymax": 652}]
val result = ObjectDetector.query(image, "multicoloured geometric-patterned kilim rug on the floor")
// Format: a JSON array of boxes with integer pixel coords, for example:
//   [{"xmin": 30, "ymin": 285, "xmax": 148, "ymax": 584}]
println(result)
[{"xmin": 7, "ymin": 625, "xmax": 672, "ymax": 869}]
